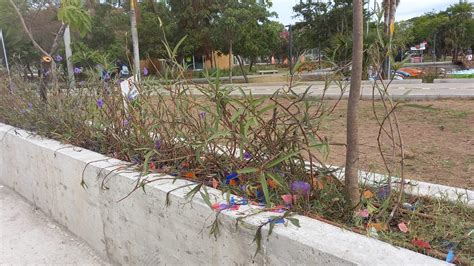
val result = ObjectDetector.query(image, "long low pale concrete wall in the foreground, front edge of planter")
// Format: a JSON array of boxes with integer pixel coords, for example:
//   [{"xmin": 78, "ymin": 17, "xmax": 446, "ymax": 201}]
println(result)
[{"xmin": 0, "ymin": 124, "xmax": 444, "ymax": 265}]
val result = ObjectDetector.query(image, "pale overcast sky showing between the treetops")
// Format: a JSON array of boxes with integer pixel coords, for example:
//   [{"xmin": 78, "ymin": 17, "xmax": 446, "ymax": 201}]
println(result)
[{"xmin": 271, "ymin": 0, "xmax": 459, "ymax": 25}]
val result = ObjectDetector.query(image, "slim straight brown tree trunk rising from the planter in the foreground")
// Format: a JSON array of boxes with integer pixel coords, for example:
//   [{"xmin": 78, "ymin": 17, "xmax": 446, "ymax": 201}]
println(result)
[{"xmin": 345, "ymin": 0, "xmax": 364, "ymax": 209}]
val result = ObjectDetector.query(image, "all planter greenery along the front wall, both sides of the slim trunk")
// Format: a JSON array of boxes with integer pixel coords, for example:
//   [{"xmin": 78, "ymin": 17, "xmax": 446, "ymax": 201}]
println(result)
[{"xmin": 0, "ymin": 20, "xmax": 473, "ymax": 259}]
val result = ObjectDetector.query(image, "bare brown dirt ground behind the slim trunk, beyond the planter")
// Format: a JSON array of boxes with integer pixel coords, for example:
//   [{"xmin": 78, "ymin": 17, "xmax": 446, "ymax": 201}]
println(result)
[{"xmin": 323, "ymin": 100, "xmax": 474, "ymax": 189}]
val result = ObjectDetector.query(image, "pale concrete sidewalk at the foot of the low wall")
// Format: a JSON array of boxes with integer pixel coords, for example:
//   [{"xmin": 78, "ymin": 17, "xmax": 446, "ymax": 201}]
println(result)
[{"xmin": 0, "ymin": 184, "xmax": 105, "ymax": 265}]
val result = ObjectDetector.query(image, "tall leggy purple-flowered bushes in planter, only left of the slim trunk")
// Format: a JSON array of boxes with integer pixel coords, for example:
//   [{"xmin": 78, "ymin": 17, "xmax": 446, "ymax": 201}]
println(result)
[{"xmin": 0, "ymin": 46, "xmax": 344, "ymax": 212}]
